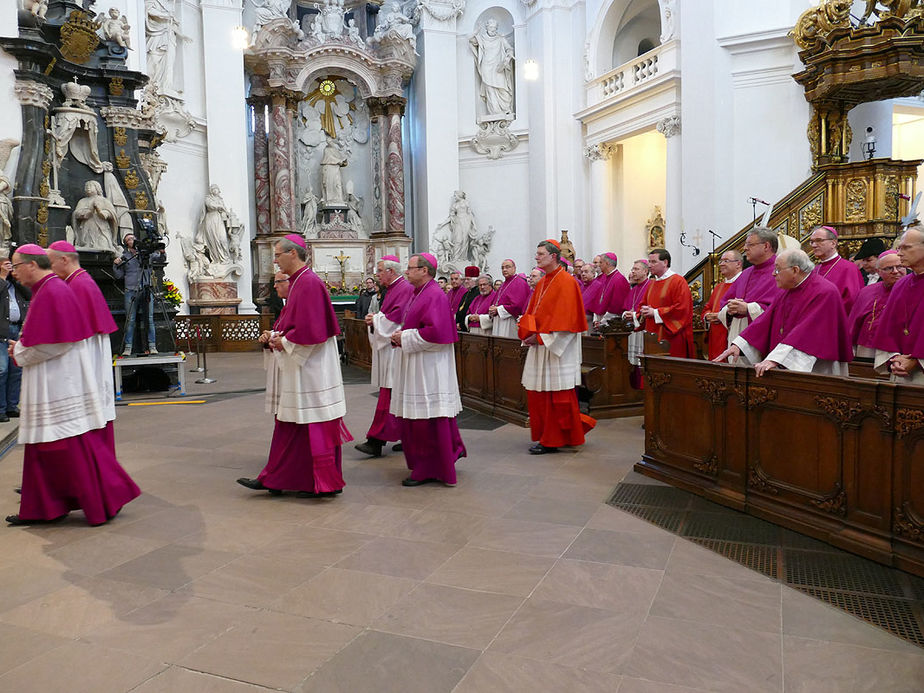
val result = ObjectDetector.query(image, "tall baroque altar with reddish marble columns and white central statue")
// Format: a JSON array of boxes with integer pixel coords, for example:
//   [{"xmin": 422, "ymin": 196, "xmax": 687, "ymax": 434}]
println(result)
[{"xmin": 244, "ymin": 0, "xmax": 417, "ymax": 305}]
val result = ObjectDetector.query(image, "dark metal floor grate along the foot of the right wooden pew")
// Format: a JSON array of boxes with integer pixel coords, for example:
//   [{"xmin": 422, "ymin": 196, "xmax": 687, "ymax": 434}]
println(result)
[{"xmin": 607, "ymin": 483, "xmax": 924, "ymax": 647}]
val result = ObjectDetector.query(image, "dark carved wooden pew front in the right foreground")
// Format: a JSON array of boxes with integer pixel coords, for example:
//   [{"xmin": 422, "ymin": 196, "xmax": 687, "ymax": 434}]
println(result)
[{"xmin": 635, "ymin": 357, "xmax": 924, "ymax": 576}]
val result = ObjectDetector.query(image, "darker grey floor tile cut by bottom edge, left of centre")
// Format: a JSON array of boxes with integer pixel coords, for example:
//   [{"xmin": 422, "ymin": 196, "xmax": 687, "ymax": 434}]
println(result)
[{"xmin": 300, "ymin": 631, "xmax": 480, "ymax": 693}]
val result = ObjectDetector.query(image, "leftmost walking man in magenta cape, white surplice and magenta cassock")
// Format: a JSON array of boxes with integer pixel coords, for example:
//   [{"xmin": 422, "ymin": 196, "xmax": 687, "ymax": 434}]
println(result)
[{"xmin": 6, "ymin": 244, "xmax": 141, "ymax": 525}]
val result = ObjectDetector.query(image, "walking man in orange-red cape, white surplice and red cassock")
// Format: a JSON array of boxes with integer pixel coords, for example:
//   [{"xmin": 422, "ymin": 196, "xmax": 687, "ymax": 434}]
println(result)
[{"xmin": 518, "ymin": 240, "xmax": 596, "ymax": 455}]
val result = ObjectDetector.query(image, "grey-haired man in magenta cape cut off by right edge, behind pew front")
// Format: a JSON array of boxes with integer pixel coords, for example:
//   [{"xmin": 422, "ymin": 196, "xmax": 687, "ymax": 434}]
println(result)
[{"xmin": 873, "ymin": 230, "xmax": 924, "ymax": 385}]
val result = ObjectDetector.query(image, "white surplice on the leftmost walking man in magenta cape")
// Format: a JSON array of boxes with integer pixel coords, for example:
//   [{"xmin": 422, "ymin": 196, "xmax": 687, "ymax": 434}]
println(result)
[{"xmin": 13, "ymin": 337, "xmax": 109, "ymax": 444}]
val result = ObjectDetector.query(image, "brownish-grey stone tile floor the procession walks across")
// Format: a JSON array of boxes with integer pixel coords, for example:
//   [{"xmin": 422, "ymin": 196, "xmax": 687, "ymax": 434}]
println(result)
[{"xmin": 0, "ymin": 354, "xmax": 924, "ymax": 693}]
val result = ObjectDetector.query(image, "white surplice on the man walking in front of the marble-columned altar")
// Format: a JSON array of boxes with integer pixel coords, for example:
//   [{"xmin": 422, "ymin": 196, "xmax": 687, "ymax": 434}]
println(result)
[{"xmin": 264, "ymin": 337, "xmax": 346, "ymax": 424}]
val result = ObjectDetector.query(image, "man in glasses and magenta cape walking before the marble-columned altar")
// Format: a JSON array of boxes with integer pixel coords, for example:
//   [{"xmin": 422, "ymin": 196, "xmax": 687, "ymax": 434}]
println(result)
[{"xmin": 237, "ymin": 234, "xmax": 353, "ymax": 498}]
